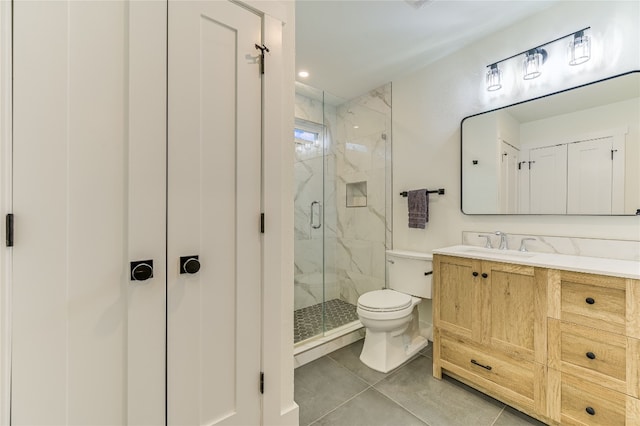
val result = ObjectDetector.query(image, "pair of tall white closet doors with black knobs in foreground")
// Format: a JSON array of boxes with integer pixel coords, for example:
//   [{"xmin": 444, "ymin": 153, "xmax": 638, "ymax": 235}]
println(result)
[{"xmin": 11, "ymin": 1, "xmax": 262, "ymax": 425}]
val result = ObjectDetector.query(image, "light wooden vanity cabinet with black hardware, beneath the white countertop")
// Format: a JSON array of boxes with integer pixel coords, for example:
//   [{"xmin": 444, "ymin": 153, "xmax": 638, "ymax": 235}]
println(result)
[{"xmin": 433, "ymin": 254, "xmax": 640, "ymax": 426}]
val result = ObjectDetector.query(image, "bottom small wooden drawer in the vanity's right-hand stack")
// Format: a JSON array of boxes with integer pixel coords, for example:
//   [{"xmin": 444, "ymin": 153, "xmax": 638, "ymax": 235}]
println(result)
[{"xmin": 560, "ymin": 373, "xmax": 631, "ymax": 426}]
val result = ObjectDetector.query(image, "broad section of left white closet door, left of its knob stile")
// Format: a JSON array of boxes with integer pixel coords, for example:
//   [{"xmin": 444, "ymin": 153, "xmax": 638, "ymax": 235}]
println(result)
[{"xmin": 11, "ymin": 1, "xmax": 144, "ymax": 425}]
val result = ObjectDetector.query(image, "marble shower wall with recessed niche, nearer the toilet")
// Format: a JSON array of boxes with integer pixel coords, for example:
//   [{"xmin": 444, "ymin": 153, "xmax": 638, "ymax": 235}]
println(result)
[{"xmin": 336, "ymin": 84, "xmax": 391, "ymax": 304}]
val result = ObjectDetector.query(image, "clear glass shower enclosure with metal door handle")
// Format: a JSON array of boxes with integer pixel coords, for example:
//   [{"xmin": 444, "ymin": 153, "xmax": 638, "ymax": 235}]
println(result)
[{"xmin": 293, "ymin": 83, "xmax": 391, "ymax": 344}]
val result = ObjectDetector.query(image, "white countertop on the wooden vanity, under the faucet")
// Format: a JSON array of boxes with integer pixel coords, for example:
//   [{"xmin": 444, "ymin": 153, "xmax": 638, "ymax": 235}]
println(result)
[{"xmin": 433, "ymin": 245, "xmax": 640, "ymax": 280}]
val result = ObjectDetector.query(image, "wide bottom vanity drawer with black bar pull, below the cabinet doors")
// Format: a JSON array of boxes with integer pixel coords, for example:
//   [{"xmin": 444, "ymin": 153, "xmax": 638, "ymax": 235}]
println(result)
[{"xmin": 440, "ymin": 332, "xmax": 536, "ymax": 400}]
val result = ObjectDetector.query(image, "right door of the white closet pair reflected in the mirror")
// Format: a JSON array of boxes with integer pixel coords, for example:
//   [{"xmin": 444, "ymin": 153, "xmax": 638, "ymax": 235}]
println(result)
[{"xmin": 567, "ymin": 137, "xmax": 613, "ymax": 214}]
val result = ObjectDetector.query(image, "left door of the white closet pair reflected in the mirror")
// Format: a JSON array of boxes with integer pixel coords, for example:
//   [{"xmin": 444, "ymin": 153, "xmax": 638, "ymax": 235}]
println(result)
[{"xmin": 529, "ymin": 145, "xmax": 567, "ymax": 214}]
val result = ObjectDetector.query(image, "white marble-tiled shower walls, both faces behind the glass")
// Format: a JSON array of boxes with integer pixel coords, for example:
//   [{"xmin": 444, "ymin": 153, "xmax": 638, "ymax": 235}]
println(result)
[{"xmin": 294, "ymin": 84, "xmax": 392, "ymax": 309}]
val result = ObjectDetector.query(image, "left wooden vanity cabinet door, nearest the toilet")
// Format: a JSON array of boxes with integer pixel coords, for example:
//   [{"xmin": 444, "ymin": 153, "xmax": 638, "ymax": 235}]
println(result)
[{"xmin": 433, "ymin": 256, "xmax": 482, "ymax": 342}]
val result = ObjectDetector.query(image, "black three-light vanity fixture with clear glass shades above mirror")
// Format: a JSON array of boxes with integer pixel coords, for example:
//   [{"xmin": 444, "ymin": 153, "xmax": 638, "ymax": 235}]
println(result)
[{"xmin": 485, "ymin": 27, "xmax": 591, "ymax": 92}]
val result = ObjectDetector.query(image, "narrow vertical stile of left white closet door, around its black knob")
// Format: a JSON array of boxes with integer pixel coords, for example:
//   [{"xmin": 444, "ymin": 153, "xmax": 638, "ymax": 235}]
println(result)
[{"xmin": 123, "ymin": 1, "xmax": 167, "ymax": 425}]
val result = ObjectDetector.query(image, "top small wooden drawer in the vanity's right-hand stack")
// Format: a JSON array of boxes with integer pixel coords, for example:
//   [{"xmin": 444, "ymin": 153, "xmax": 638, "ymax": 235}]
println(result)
[{"xmin": 560, "ymin": 272, "xmax": 626, "ymax": 334}]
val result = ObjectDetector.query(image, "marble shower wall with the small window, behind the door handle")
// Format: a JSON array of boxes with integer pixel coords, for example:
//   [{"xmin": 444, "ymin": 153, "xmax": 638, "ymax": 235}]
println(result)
[{"xmin": 293, "ymin": 94, "xmax": 340, "ymax": 309}]
